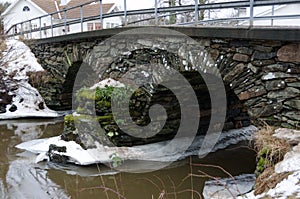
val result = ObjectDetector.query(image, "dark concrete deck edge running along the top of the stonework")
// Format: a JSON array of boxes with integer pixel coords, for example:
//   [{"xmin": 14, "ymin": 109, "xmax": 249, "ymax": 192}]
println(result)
[{"xmin": 32, "ymin": 26, "xmax": 300, "ymax": 43}]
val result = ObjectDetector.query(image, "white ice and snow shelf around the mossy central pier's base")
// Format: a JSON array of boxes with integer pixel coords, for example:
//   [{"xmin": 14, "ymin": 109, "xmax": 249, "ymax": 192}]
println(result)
[{"xmin": 16, "ymin": 126, "xmax": 257, "ymax": 165}]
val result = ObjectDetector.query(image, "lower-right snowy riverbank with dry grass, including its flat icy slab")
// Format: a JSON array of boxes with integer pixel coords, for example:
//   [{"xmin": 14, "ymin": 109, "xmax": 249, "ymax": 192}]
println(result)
[{"xmin": 204, "ymin": 126, "xmax": 300, "ymax": 199}]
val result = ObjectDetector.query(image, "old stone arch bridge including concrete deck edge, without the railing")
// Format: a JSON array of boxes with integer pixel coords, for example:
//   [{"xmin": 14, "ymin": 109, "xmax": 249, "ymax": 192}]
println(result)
[{"xmin": 28, "ymin": 27, "xmax": 300, "ymax": 131}]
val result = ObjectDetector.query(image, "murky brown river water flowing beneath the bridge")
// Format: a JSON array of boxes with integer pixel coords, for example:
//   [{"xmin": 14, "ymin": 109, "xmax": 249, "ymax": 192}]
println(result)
[{"xmin": 0, "ymin": 119, "xmax": 255, "ymax": 199}]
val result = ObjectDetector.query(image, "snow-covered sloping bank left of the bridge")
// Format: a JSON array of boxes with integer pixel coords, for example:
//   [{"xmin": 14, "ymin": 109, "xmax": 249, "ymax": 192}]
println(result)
[{"xmin": 0, "ymin": 39, "xmax": 59, "ymax": 119}]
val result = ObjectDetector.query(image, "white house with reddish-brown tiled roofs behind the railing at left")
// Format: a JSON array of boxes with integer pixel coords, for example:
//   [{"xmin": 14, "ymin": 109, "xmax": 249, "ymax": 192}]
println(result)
[{"xmin": 2, "ymin": 0, "xmax": 122, "ymax": 38}]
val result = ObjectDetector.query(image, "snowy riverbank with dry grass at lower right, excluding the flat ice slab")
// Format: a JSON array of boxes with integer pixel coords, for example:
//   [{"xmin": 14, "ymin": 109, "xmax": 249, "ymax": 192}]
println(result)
[{"xmin": 239, "ymin": 127, "xmax": 300, "ymax": 199}]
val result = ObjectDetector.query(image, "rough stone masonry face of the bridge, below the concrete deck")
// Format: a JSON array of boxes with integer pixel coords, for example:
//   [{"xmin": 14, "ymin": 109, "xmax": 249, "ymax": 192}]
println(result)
[{"xmin": 30, "ymin": 33, "xmax": 300, "ymax": 128}]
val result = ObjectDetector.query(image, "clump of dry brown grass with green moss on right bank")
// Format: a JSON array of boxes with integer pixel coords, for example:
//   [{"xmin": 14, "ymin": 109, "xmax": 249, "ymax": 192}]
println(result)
[{"xmin": 255, "ymin": 125, "xmax": 291, "ymax": 195}]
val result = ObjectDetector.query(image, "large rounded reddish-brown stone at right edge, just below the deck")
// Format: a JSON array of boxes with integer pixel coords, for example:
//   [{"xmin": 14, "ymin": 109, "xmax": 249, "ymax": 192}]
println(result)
[{"xmin": 277, "ymin": 43, "xmax": 300, "ymax": 62}]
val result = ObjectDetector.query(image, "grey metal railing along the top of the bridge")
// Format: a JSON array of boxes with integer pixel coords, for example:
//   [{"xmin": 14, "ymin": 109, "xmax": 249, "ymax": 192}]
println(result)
[{"xmin": 6, "ymin": 0, "xmax": 300, "ymax": 38}]
